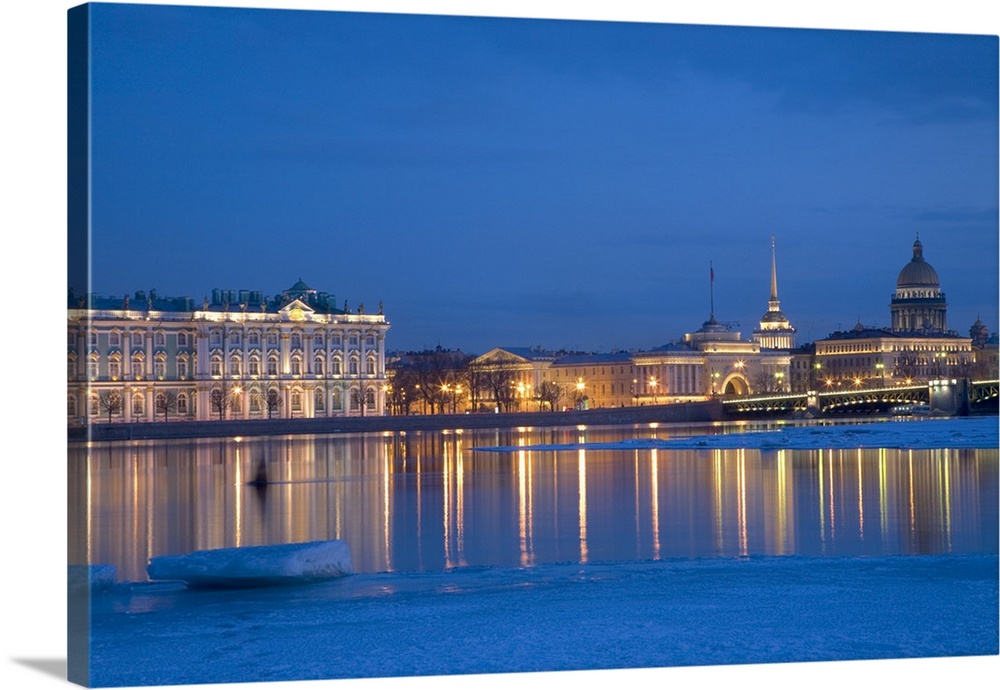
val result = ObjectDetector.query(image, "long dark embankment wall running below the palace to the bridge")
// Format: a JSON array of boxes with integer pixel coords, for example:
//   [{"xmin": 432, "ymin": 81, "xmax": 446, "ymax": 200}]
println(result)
[{"xmin": 69, "ymin": 401, "xmax": 724, "ymax": 442}]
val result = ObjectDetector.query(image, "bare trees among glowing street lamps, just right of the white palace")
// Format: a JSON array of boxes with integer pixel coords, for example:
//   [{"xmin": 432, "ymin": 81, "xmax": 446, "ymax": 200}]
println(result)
[{"xmin": 386, "ymin": 347, "xmax": 564, "ymax": 415}]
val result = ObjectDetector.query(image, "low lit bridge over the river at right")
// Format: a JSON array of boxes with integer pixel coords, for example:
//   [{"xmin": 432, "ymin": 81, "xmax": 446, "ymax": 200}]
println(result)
[{"xmin": 722, "ymin": 379, "xmax": 1000, "ymax": 418}]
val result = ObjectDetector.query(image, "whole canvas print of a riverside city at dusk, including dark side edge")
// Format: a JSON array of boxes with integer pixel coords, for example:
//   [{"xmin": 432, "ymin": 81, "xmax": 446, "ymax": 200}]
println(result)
[{"xmin": 66, "ymin": 3, "xmax": 1000, "ymax": 687}]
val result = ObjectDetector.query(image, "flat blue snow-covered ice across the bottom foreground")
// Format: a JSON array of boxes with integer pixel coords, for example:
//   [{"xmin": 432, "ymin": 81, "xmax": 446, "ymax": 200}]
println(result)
[{"xmin": 92, "ymin": 554, "xmax": 998, "ymax": 686}]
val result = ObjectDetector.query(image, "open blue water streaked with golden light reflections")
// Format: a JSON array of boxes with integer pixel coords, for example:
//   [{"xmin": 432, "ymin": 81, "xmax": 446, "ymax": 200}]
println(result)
[{"xmin": 69, "ymin": 426, "xmax": 998, "ymax": 581}]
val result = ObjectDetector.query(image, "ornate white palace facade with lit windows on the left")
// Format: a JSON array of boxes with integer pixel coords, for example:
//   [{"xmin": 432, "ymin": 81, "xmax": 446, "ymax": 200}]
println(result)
[{"xmin": 67, "ymin": 280, "xmax": 389, "ymax": 424}]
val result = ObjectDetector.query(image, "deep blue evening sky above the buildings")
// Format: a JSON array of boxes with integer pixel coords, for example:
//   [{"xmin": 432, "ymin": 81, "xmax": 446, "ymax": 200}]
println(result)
[{"xmin": 84, "ymin": 4, "xmax": 1000, "ymax": 352}]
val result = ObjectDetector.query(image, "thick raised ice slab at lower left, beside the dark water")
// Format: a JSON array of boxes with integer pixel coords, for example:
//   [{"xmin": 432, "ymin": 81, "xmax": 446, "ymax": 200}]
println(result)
[{"xmin": 146, "ymin": 539, "xmax": 353, "ymax": 587}]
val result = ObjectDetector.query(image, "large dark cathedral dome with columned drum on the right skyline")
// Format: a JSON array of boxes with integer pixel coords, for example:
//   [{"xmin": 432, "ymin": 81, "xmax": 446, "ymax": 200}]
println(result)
[{"xmin": 889, "ymin": 237, "xmax": 948, "ymax": 333}]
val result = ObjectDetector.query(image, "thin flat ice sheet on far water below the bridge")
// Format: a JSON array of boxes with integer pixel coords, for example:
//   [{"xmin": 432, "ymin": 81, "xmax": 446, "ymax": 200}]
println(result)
[{"xmin": 476, "ymin": 416, "xmax": 1000, "ymax": 452}]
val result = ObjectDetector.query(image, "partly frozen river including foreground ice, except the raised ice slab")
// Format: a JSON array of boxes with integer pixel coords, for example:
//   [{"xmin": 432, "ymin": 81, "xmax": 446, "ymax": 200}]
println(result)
[{"xmin": 69, "ymin": 417, "xmax": 998, "ymax": 686}]
